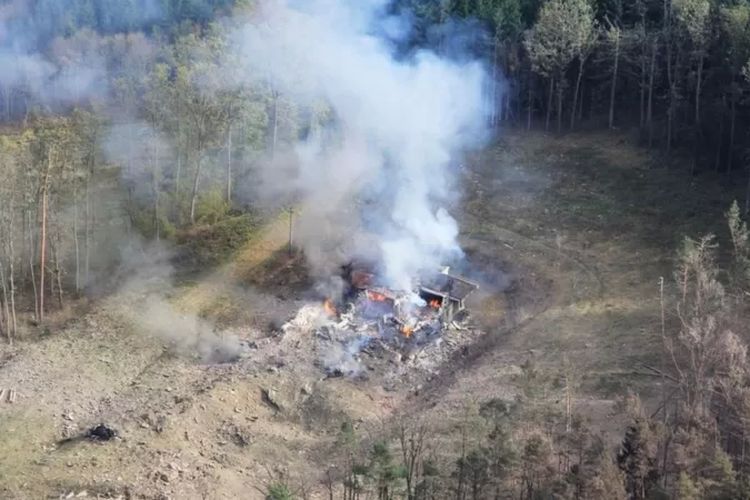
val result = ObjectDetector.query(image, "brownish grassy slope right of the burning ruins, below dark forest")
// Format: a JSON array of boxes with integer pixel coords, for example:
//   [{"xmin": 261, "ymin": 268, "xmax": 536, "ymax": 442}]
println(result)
[{"xmin": 414, "ymin": 131, "xmax": 731, "ymax": 443}]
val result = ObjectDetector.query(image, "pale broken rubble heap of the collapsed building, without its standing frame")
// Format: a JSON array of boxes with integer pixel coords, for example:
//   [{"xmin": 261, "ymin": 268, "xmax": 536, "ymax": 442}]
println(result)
[{"xmin": 280, "ymin": 288, "xmax": 475, "ymax": 376}]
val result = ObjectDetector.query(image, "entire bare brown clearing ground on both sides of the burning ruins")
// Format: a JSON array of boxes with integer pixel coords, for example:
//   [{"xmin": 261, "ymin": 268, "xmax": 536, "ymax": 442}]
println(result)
[{"xmin": 0, "ymin": 131, "xmax": 730, "ymax": 499}]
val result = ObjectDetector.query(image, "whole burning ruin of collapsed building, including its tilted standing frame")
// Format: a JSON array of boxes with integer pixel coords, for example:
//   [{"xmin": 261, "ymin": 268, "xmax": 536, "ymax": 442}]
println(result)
[{"xmin": 282, "ymin": 266, "xmax": 479, "ymax": 377}]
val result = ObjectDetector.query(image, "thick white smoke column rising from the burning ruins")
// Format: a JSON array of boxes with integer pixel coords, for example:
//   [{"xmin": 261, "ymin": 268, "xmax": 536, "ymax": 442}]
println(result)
[{"xmin": 236, "ymin": 0, "xmax": 494, "ymax": 290}]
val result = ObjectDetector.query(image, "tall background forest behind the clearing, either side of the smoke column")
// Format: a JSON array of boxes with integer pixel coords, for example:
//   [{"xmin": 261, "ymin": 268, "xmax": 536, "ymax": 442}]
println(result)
[{"xmin": 0, "ymin": 0, "xmax": 750, "ymax": 328}]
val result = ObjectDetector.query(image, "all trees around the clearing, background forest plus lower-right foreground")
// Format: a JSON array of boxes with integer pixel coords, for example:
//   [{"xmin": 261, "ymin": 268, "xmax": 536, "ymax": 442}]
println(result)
[{"xmin": 0, "ymin": 0, "xmax": 750, "ymax": 500}]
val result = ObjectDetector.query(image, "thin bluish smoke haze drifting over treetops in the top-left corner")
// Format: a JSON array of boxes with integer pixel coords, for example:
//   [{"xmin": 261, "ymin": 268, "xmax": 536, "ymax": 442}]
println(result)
[{"xmin": 0, "ymin": 0, "xmax": 197, "ymax": 110}]
